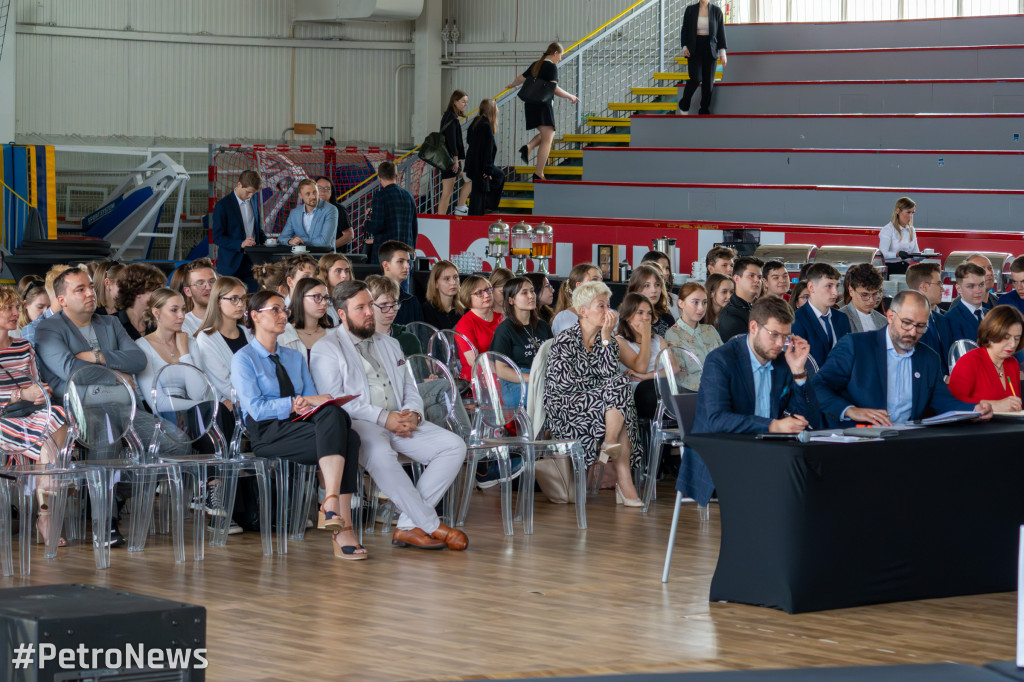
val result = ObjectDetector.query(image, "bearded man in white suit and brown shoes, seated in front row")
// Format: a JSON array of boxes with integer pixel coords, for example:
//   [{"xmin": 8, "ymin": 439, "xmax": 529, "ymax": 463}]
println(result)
[{"xmin": 309, "ymin": 281, "xmax": 469, "ymax": 550}]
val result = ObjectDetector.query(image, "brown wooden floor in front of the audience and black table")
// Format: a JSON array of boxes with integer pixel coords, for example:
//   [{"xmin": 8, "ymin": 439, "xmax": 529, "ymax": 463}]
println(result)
[{"xmin": 6, "ymin": 477, "xmax": 1016, "ymax": 681}]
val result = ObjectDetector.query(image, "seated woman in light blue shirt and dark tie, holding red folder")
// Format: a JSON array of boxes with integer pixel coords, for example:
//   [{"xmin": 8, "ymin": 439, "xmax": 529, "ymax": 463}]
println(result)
[{"xmin": 231, "ymin": 290, "xmax": 367, "ymax": 560}]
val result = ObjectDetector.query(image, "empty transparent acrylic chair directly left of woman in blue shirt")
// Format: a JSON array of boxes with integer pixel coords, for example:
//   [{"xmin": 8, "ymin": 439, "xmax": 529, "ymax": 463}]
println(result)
[{"xmin": 147, "ymin": 363, "xmax": 273, "ymax": 561}]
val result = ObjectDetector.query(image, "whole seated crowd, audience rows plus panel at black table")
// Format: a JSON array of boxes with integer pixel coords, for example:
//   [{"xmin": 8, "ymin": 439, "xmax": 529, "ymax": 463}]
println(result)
[{"xmin": 8, "ymin": 164, "xmax": 1024, "ymax": 560}]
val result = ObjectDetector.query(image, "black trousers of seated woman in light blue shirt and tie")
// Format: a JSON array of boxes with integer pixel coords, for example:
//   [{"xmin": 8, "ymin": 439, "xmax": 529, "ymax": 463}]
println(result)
[{"xmin": 246, "ymin": 404, "xmax": 360, "ymax": 495}]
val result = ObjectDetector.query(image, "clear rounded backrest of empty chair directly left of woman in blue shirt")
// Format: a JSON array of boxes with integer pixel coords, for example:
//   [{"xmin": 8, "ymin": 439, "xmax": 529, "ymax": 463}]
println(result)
[{"xmin": 148, "ymin": 363, "xmax": 228, "ymax": 459}]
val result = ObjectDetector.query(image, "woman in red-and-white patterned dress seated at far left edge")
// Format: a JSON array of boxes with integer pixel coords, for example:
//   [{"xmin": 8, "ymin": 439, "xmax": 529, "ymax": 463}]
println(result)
[{"xmin": 0, "ymin": 286, "xmax": 68, "ymax": 546}]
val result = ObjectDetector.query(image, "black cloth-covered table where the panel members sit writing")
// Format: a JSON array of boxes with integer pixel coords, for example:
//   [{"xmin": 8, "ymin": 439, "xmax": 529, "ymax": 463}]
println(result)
[{"xmin": 686, "ymin": 423, "xmax": 1024, "ymax": 613}]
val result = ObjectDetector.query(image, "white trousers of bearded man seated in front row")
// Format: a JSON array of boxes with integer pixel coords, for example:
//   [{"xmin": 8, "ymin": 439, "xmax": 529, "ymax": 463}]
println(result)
[{"xmin": 352, "ymin": 419, "xmax": 466, "ymax": 534}]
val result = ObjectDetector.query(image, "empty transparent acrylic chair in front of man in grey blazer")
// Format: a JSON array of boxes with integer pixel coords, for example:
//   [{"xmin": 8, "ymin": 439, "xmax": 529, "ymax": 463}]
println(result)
[{"xmin": 65, "ymin": 365, "xmax": 185, "ymax": 568}]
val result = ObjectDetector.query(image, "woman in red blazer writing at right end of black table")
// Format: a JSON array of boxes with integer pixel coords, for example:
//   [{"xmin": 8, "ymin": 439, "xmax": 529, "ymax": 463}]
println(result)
[{"xmin": 949, "ymin": 305, "xmax": 1024, "ymax": 412}]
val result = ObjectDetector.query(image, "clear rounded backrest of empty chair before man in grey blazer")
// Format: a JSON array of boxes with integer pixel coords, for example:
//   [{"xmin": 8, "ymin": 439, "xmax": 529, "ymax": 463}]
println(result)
[{"xmin": 65, "ymin": 365, "xmax": 142, "ymax": 461}]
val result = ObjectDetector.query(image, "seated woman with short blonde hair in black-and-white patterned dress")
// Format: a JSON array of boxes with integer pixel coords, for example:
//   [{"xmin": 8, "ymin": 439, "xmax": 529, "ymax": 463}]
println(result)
[{"xmin": 544, "ymin": 282, "xmax": 643, "ymax": 507}]
